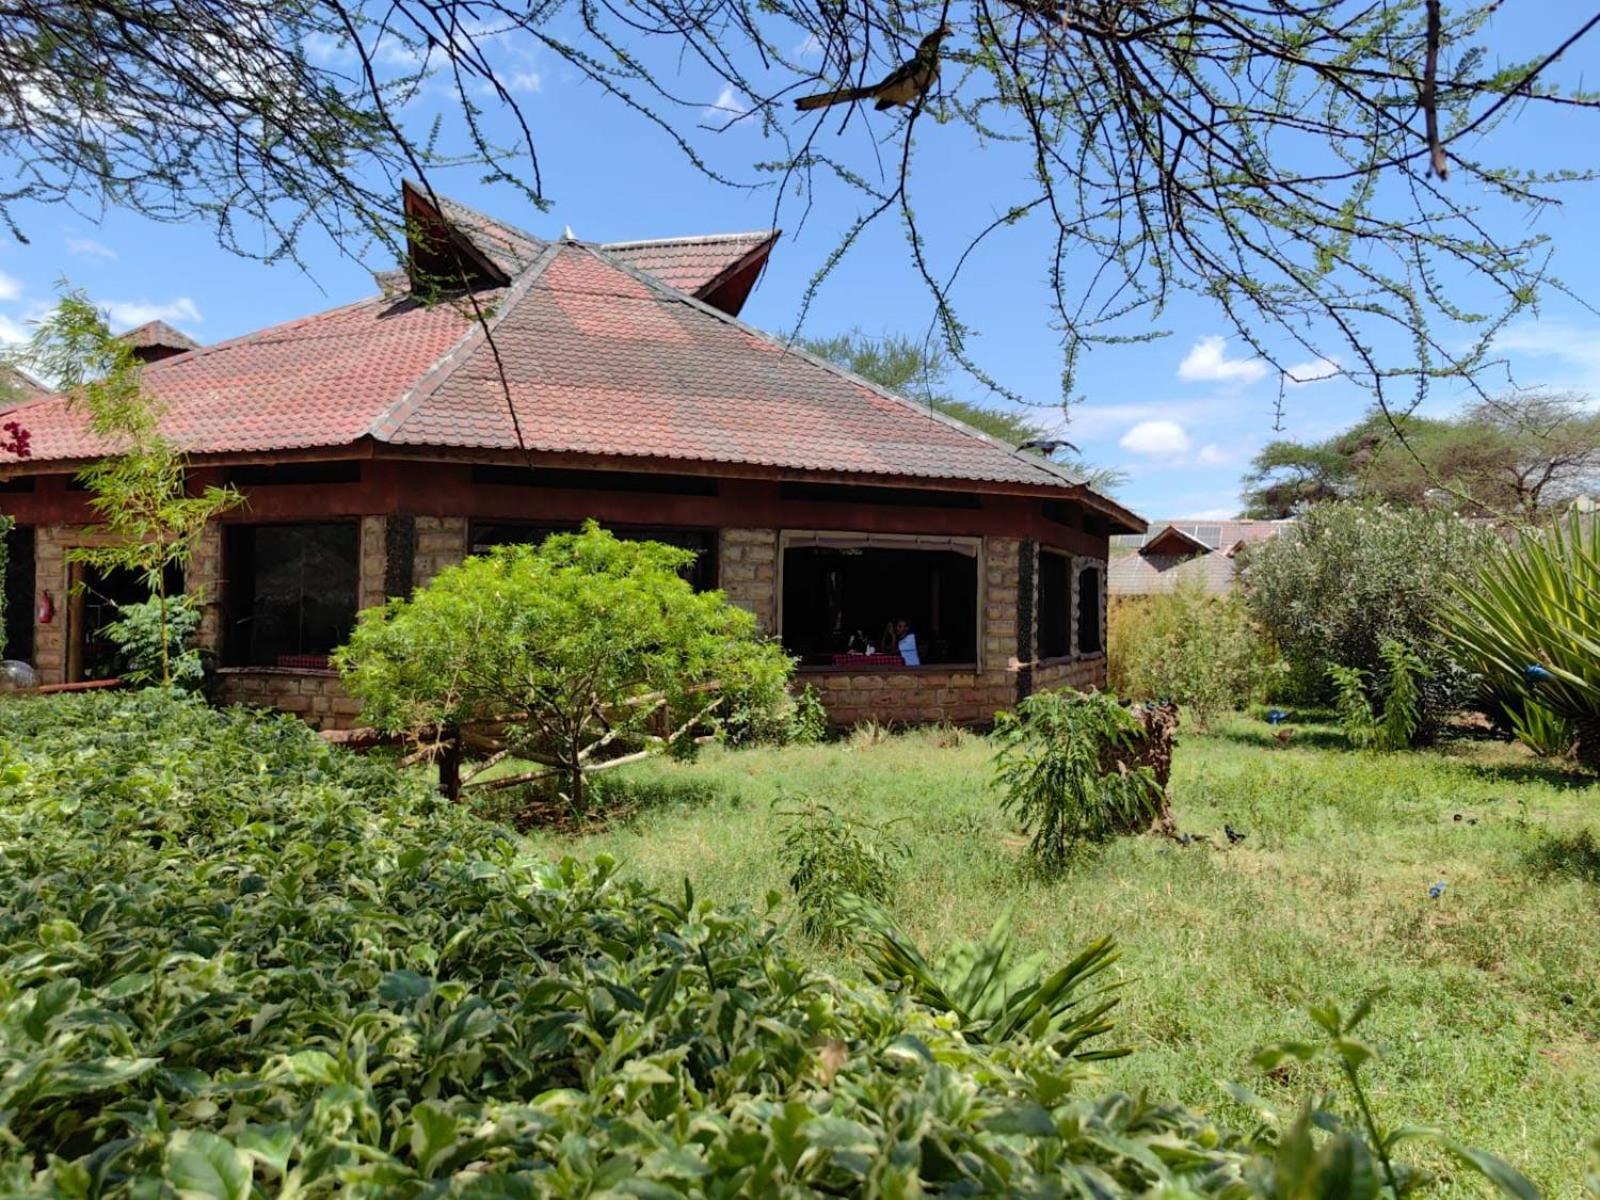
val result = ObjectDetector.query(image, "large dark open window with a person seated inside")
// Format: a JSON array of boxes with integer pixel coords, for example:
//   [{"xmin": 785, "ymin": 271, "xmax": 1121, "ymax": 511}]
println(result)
[{"xmin": 782, "ymin": 536, "xmax": 978, "ymax": 667}]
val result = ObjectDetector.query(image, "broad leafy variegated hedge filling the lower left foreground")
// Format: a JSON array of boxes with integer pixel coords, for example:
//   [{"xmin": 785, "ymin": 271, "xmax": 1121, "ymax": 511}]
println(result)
[{"xmin": 0, "ymin": 690, "xmax": 1530, "ymax": 1200}]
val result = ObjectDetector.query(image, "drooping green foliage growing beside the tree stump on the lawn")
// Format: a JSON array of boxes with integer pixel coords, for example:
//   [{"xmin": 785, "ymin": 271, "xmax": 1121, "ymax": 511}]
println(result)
[{"xmin": 995, "ymin": 691, "xmax": 1163, "ymax": 872}]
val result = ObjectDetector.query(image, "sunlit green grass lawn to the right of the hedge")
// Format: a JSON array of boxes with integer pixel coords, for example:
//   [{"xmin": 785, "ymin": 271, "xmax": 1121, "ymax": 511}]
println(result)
[{"xmin": 515, "ymin": 718, "xmax": 1600, "ymax": 1197}]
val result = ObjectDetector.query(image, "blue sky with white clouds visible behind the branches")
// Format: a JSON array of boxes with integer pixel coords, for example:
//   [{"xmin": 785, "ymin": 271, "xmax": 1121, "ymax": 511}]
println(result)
[{"xmin": 0, "ymin": 0, "xmax": 1600, "ymax": 517}]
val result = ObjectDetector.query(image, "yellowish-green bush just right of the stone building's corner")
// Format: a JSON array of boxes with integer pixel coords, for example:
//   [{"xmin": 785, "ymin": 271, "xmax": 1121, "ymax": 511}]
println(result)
[{"xmin": 1109, "ymin": 581, "xmax": 1277, "ymax": 723}]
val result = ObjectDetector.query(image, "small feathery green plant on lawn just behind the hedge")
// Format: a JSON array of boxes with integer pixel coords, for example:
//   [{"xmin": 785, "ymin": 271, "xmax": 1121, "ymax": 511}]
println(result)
[{"xmin": 779, "ymin": 802, "xmax": 910, "ymax": 944}]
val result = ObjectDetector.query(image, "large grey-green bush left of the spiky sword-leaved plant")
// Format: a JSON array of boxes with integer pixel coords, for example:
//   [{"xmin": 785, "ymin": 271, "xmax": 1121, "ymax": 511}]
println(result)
[{"xmin": 1240, "ymin": 504, "xmax": 1499, "ymax": 739}]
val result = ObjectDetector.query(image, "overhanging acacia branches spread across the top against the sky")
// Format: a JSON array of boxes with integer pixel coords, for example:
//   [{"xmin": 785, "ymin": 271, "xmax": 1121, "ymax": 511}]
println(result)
[{"xmin": 0, "ymin": 0, "xmax": 1600, "ymax": 435}]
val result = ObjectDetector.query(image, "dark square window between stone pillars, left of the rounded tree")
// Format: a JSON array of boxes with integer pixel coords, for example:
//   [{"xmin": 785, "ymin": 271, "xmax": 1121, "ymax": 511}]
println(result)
[{"xmin": 224, "ymin": 522, "xmax": 360, "ymax": 669}]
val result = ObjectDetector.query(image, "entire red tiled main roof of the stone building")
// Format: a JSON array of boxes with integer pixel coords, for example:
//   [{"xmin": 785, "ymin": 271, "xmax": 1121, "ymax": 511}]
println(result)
[{"xmin": 0, "ymin": 188, "xmax": 1138, "ymax": 528}]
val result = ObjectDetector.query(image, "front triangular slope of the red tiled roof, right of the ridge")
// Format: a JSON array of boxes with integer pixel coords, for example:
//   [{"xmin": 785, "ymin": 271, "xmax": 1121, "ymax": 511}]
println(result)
[{"xmin": 373, "ymin": 243, "xmax": 1072, "ymax": 486}]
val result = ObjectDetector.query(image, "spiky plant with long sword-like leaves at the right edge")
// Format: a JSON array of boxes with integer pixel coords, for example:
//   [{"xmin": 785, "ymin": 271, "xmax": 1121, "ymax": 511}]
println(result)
[{"xmin": 1440, "ymin": 514, "xmax": 1600, "ymax": 771}]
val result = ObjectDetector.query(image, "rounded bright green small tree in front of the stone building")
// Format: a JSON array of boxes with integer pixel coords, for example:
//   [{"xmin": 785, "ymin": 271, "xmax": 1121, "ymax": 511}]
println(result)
[{"xmin": 336, "ymin": 522, "xmax": 792, "ymax": 811}]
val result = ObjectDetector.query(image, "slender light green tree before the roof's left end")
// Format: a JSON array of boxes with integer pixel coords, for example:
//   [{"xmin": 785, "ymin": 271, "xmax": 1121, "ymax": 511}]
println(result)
[{"xmin": 30, "ymin": 293, "xmax": 245, "ymax": 686}]
